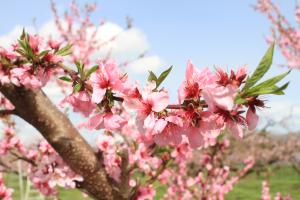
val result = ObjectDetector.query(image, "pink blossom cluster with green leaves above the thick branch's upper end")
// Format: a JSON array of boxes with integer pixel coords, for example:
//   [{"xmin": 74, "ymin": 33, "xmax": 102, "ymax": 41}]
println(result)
[{"xmin": 0, "ymin": 33, "xmax": 65, "ymax": 89}]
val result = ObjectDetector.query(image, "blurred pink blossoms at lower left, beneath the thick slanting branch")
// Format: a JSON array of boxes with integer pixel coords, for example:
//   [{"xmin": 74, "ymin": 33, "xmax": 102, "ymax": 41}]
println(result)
[{"xmin": 0, "ymin": 127, "xmax": 82, "ymax": 197}]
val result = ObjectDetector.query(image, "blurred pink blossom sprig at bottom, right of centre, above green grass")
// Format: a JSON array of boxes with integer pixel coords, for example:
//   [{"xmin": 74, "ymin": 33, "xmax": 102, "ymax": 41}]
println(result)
[{"xmin": 159, "ymin": 139, "xmax": 254, "ymax": 200}]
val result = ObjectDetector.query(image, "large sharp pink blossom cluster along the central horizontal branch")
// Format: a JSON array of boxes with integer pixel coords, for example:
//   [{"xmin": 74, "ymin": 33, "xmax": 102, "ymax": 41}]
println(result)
[{"xmin": 62, "ymin": 60, "xmax": 264, "ymax": 148}]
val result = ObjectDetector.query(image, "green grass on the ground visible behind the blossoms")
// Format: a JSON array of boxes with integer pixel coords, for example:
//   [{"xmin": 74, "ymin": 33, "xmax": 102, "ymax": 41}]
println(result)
[{"xmin": 6, "ymin": 167, "xmax": 300, "ymax": 200}]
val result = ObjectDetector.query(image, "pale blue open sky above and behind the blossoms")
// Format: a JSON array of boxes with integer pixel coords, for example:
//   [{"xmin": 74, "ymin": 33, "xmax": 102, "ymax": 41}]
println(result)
[{"xmin": 0, "ymin": 0, "xmax": 300, "ymax": 134}]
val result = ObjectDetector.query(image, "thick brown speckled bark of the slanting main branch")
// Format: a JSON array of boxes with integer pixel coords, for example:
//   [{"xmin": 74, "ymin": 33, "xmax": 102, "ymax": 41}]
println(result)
[{"xmin": 0, "ymin": 85, "xmax": 120, "ymax": 200}]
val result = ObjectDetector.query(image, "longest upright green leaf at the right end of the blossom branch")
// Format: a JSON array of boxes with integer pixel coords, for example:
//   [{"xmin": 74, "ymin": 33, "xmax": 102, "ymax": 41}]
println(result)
[{"xmin": 242, "ymin": 43, "xmax": 274, "ymax": 92}]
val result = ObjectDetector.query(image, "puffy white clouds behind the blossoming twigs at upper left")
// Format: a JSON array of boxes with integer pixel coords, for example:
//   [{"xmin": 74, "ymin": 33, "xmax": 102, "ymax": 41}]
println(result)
[{"xmin": 0, "ymin": 20, "xmax": 165, "ymax": 74}]
